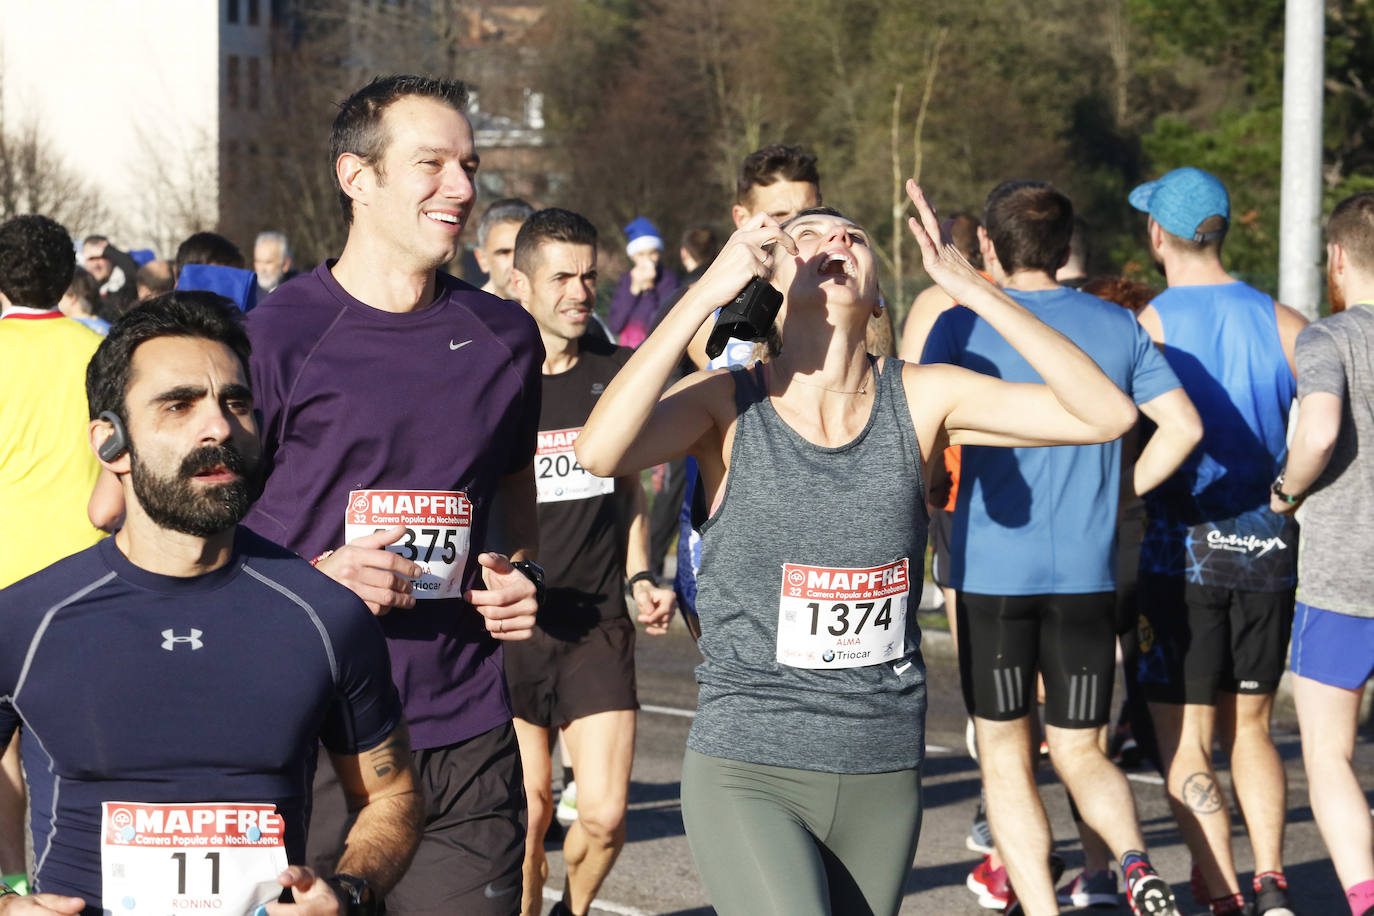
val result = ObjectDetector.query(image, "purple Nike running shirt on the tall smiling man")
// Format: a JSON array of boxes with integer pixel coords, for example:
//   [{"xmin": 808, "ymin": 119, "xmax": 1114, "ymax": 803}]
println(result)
[{"xmin": 245, "ymin": 262, "xmax": 544, "ymax": 748}]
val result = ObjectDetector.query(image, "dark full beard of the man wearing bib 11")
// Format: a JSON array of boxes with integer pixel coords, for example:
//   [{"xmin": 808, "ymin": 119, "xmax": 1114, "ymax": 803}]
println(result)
[{"xmin": 129, "ymin": 445, "xmax": 257, "ymax": 537}]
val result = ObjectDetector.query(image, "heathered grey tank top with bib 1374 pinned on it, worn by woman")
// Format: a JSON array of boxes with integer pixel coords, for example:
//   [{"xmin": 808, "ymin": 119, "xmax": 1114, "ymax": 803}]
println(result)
[{"xmin": 687, "ymin": 357, "xmax": 927, "ymax": 773}]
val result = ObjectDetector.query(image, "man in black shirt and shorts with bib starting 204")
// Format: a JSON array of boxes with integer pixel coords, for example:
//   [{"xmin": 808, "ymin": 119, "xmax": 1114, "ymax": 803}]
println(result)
[{"xmin": 506, "ymin": 209, "xmax": 676, "ymax": 916}]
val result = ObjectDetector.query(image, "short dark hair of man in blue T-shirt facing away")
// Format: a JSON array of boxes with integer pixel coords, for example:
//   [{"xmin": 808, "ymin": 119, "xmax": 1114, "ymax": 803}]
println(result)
[{"xmin": 982, "ymin": 181, "xmax": 1073, "ymax": 276}]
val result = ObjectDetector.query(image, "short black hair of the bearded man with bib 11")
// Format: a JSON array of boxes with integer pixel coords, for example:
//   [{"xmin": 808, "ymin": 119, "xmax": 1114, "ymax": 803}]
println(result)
[{"xmin": 87, "ymin": 290, "xmax": 253, "ymax": 420}]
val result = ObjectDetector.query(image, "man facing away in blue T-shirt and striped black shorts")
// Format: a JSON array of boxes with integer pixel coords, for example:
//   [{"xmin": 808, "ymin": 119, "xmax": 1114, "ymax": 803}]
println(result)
[{"xmin": 922, "ymin": 181, "xmax": 1201, "ymax": 913}]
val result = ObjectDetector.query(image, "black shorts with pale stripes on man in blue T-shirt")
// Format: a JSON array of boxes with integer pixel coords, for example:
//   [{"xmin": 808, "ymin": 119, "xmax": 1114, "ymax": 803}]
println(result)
[{"xmin": 956, "ymin": 592, "xmax": 1116, "ymax": 728}]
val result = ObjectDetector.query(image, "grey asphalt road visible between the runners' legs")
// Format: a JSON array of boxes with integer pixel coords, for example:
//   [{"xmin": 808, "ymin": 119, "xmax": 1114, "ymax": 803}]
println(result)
[{"xmin": 533, "ymin": 596, "xmax": 1374, "ymax": 916}]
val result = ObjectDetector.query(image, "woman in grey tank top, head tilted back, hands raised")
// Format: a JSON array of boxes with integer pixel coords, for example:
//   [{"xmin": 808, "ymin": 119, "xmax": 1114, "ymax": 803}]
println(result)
[{"xmin": 577, "ymin": 181, "xmax": 1135, "ymax": 916}]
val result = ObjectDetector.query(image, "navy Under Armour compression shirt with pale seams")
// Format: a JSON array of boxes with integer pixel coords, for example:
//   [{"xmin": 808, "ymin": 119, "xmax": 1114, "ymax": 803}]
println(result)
[{"xmin": 0, "ymin": 529, "xmax": 403, "ymax": 913}]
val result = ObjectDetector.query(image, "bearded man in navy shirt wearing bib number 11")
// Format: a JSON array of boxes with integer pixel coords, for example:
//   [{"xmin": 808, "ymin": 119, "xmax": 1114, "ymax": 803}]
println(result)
[{"xmin": 0, "ymin": 293, "xmax": 422, "ymax": 916}]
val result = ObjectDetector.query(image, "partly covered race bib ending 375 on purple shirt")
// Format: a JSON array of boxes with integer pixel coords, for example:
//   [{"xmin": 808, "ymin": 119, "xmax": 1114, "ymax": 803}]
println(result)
[{"xmin": 344, "ymin": 490, "xmax": 473, "ymax": 599}]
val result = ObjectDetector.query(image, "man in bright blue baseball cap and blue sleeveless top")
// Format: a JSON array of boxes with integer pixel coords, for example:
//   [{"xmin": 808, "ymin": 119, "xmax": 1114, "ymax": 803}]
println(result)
[{"xmin": 1131, "ymin": 168, "xmax": 1307, "ymax": 916}]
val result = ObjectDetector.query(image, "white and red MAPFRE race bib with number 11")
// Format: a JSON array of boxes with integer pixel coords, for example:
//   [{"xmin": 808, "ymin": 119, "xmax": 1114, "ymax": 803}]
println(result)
[{"xmin": 100, "ymin": 802, "xmax": 287, "ymax": 916}]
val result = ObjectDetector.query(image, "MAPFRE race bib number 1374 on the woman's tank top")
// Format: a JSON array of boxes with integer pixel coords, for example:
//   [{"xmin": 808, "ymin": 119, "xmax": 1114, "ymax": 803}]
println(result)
[{"xmin": 778, "ymin": 558, "xmax": 911, "ymax": 667}]
